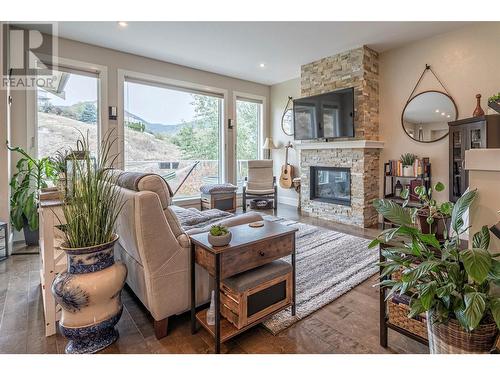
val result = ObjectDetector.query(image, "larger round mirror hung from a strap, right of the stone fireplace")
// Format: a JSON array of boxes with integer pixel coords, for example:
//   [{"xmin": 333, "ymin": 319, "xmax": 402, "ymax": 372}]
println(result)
[{"xmin": 401, "ymin": 91, "xmax": 458, "ymax": 143}]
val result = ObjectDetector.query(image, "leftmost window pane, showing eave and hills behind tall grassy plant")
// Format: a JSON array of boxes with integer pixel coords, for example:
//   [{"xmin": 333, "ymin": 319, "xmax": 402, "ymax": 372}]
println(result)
[{"xmin": 36, "ymin": 70, "xmax": 99, "ymax": 157}]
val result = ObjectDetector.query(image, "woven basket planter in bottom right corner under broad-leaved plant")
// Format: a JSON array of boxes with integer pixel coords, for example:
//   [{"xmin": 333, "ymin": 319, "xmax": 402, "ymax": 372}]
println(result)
[{"xmin": 427, "ymin": 313, "xmax": 498, "ymax": 354}]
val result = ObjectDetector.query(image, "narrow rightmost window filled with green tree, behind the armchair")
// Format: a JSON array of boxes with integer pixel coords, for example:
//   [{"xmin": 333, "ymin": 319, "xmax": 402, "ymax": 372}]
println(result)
[{"xmin": 236, "ymin": 98, "xmax": 262, "ymax": 186}]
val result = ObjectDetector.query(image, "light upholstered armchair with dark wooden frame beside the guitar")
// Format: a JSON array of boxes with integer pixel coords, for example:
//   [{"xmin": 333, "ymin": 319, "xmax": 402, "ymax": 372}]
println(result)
[{"xmin": 242, "ymin": 160, "xmax": 278, "ymax": 212}]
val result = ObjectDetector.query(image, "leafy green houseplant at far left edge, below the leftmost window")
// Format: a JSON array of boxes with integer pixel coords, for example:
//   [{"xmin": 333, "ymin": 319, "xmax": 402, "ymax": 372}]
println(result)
[{"xmin": 7, "ymin": 142, "xmax": 56, "ymax": 245}]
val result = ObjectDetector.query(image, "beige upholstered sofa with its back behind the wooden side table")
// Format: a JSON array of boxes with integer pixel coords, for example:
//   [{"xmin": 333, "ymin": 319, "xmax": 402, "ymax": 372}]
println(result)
[{"xmin": 113, "ymin": 170, "xmax": 262, "ymax": 338}]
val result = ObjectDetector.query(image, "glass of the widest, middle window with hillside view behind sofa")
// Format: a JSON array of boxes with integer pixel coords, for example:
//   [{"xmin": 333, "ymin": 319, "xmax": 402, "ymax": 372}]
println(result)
[{"xmin": 124, "ymin": 79, "xmax": 223, "ymax": 198}]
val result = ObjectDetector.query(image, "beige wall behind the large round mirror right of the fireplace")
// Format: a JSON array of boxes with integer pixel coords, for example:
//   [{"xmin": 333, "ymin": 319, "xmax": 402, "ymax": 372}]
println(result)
[{"xmin": 379, "ymin": 22, "xmax": 500, "ymax": 200}]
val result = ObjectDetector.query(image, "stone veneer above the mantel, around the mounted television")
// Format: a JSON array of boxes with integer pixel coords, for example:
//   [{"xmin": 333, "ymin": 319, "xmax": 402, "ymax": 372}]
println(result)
[{"xmin": 300, "ymin": 46, "xmax": 379, "ymax": 141}]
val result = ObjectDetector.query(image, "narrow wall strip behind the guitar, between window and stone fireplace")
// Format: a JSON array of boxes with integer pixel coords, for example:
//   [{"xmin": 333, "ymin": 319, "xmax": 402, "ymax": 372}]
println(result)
[{"xmin": 270, "ymin": 78, "xmax": 300, "ymax": 206}]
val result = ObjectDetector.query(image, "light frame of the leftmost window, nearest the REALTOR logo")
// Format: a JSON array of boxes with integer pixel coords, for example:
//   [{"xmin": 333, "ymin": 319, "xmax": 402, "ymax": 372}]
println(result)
[{"xmin": 30, "ymin": 57, "xmax": 109, "ymax": 156}]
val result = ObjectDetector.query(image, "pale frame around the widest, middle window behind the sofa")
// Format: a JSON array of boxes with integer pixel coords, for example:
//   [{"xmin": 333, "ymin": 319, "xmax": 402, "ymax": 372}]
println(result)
[{"xmin": 117, "ymin": 69, "xmax": 229, "ymax": 204}]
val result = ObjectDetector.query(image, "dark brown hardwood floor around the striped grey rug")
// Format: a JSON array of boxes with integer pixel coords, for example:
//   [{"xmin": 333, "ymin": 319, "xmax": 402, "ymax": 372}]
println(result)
[{"xmin": 0, "ymin": 205, "xmax": 428, "ymax": 354}]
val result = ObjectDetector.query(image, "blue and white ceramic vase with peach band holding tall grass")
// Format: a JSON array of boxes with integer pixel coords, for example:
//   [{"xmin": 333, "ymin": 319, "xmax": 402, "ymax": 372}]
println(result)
[{"xmin": 52, "ymin": 234, "xmax": 127, "ymax": 354}]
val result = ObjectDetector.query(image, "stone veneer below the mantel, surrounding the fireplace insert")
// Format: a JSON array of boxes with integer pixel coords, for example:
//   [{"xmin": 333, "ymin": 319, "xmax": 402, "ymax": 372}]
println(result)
[{"xmin": 300, "ymin": 149, "xmax": 380, "ymax": 227}]
